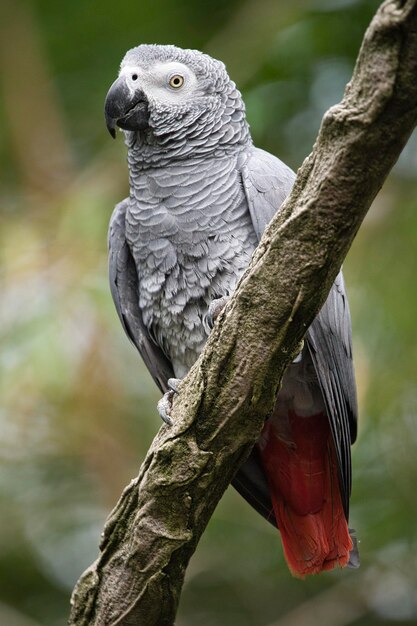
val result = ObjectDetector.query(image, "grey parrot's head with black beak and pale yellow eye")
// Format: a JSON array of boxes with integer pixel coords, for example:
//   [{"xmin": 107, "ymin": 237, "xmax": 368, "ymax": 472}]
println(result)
[{"xmin": 105, "ymin": 44, "xmax": 246, "ymax": 149}]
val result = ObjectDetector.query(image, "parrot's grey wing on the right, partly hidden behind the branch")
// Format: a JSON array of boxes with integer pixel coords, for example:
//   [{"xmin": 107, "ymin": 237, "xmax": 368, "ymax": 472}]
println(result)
[{"xmin": 237, "ymin": 148, "xmax": 357, "ymax": 521}]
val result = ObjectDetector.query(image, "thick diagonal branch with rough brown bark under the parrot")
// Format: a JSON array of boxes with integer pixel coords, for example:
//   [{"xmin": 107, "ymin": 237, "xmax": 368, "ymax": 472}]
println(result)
[{"xmin": 70, "ymin": 0, "xmax": 417, "ymax": 626}]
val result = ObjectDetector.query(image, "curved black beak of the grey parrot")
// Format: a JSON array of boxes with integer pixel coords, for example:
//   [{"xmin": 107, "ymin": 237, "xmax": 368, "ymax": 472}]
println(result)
[{"xmin": 104, "ymin": 76, "xmax": 149, "ymax": 139}]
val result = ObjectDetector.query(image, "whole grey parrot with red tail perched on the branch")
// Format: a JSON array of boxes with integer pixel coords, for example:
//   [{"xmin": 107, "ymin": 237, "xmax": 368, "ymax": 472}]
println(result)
[{"xmin": 105, "ymin": 45, "xmax": 358, "ymax": 578}]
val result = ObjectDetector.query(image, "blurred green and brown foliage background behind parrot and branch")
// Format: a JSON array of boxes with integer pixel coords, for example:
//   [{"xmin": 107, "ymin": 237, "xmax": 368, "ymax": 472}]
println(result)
[{"xmin": 0, "ymin": 0, "xmax": 417, "ymax": 626}]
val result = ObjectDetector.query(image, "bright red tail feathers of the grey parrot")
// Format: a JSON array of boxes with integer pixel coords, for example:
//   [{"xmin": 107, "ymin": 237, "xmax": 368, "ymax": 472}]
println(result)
[{"xmin": 260, "ymin": 411, "xmax": 353, "ymax": 578}]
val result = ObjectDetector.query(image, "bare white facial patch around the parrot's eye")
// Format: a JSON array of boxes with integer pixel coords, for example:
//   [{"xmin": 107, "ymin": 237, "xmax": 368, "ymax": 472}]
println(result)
[{"xmin": 119, "ymin": 61, "xmax": 198, "ymax": 104}]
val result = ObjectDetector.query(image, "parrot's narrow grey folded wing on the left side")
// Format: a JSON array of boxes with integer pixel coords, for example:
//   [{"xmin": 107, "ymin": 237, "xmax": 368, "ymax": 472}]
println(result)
[{"xmin": 109, "ymin": 200, "xmax": 174, "ymax": 392}]
